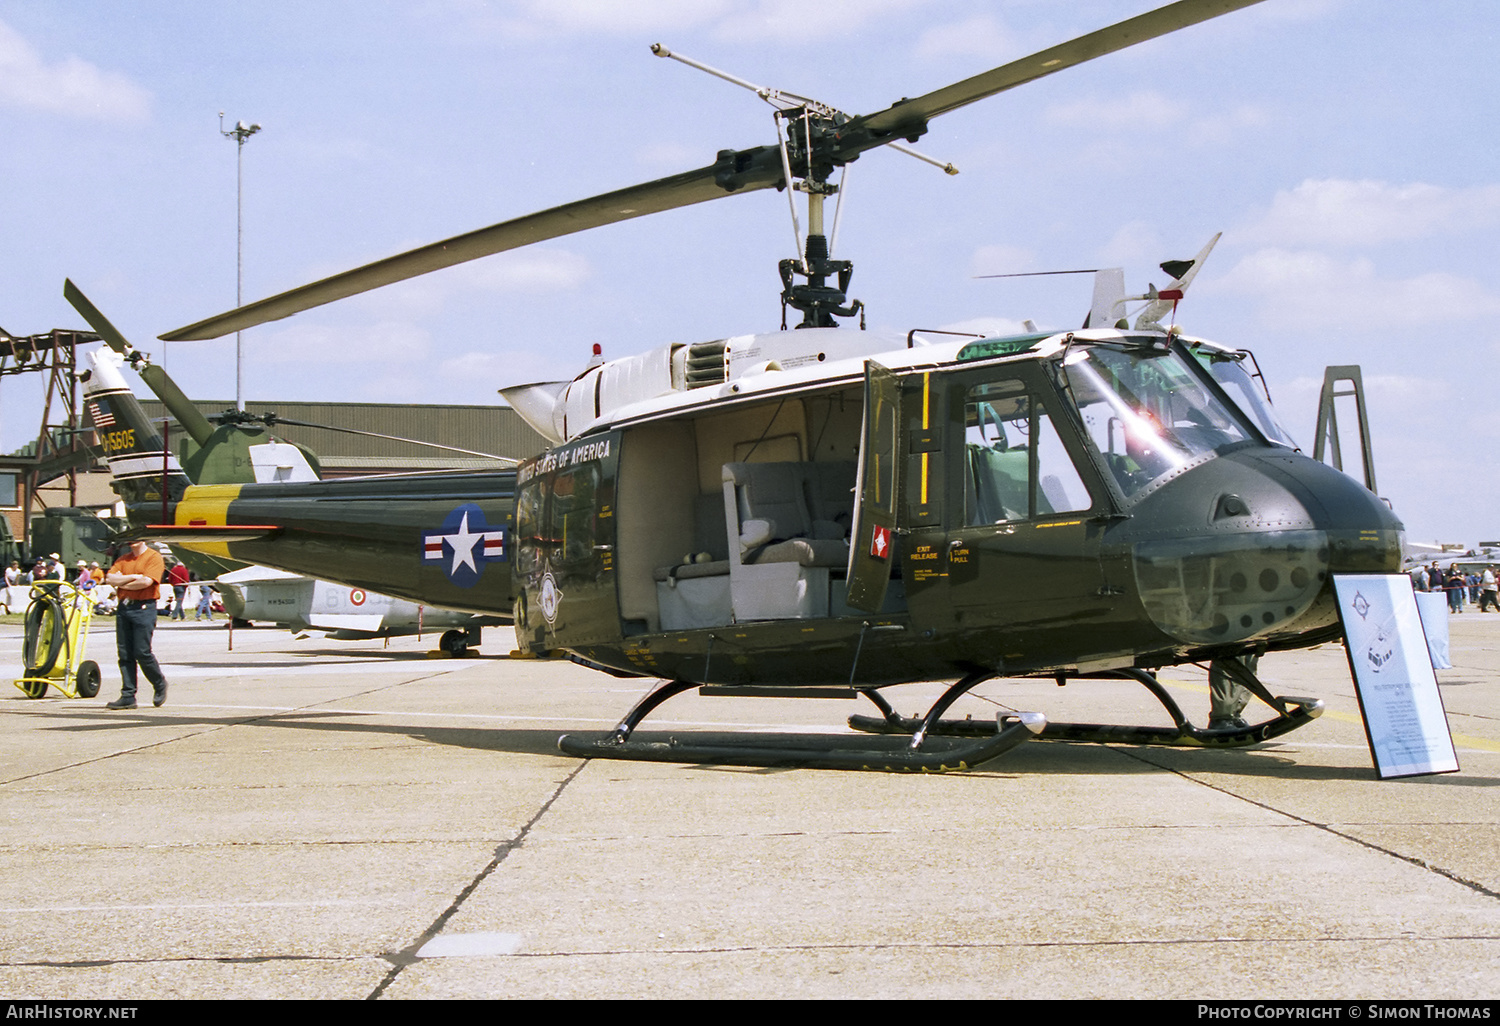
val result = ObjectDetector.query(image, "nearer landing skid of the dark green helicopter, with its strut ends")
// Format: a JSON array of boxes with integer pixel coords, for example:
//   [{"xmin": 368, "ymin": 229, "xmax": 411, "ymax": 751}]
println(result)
[{"xmin": 558, "ymin": 675, "xmax": 1047, "ymax": 773}]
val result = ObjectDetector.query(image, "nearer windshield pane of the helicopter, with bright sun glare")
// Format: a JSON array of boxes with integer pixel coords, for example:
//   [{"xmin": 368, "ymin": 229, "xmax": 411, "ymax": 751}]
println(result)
[{"xmin": 1062, "ymin": 345, "xmax": 1251, "ymax": 498}]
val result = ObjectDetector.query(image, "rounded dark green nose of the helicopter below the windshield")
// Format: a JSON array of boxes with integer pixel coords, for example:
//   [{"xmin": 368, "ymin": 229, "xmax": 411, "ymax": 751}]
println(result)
[{"xmin": 1131, "ymin": 449, "xmax": 1403, "ymax": 645}]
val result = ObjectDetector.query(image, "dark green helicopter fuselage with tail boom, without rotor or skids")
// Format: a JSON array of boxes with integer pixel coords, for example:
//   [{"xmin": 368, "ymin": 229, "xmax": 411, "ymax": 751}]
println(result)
[{"xmin": 99, "ymin": 330, "xmax": 1401, "ymax": 686}]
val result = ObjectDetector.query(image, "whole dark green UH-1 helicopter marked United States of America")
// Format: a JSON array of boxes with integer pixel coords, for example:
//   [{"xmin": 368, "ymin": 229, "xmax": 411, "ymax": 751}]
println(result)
[{"xmin": 73, "ymin": 0, "xmax": 1403, "ymax": 770}]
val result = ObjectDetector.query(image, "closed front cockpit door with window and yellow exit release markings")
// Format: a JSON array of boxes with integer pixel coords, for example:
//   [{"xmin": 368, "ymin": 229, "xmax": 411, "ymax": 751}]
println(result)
[{"xmin": 903, "ymin": 362, "xmax": 1110, "ymax": 666}]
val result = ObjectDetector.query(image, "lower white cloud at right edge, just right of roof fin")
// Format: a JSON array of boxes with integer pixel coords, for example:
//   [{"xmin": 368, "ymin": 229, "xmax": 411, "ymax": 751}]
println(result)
[{"xmin": 1217, "ymin": 249, "xmax": 1500, "ymax": 330}]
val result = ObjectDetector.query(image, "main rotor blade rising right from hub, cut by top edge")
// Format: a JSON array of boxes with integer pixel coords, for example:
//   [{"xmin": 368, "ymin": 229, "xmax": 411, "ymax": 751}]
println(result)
[{"xmin": 837, "ymin": 0, "xmax": 1262, "ymax": 159}]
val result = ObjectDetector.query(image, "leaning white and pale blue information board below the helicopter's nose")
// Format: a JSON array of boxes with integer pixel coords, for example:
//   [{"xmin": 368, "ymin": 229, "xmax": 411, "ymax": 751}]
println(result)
[{"xmin": 1334, "ymin": 573, "xmax": 1458, "ymax": 780}]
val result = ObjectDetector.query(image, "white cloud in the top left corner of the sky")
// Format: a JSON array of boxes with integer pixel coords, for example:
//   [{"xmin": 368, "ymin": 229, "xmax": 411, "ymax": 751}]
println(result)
[{"xmin": 0, "ymin": 21, "xmax": 152, "ymax": 122}]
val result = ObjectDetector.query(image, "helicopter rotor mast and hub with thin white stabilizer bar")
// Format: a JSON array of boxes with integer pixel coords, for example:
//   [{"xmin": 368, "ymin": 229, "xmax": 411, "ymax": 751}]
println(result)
[{"xmin": 651, "ymin": 44, "xmax": 959, "ymax": 327}]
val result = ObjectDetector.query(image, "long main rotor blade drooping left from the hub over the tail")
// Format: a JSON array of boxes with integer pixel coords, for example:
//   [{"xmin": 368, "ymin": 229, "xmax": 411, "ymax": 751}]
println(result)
[{"xmin": 161, "ymin": 146, "xmax": 783, "ymax": 342}]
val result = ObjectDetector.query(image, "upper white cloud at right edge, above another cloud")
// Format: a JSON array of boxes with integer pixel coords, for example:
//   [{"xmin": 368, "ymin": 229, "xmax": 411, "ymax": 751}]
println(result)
[{"xmin": 1238, "ymin": 179, "xmax": 1500, "ymax": 246}]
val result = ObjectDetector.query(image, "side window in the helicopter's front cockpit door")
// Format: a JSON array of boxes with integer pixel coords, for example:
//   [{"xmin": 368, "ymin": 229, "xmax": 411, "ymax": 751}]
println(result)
[{"xmin": 963, "ymin": 380, "xmax": 1094, "ymax": 527}]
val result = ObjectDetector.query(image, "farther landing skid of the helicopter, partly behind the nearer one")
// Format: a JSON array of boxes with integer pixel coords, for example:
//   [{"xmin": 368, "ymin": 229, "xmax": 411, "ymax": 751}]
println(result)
[{"xmin": 849, "ymin": 666, "xmax": 1323, "ymax": 749}]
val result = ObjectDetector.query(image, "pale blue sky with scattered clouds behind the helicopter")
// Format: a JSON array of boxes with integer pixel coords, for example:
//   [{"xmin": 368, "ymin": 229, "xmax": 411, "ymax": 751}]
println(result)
[{"xmin": 0, "ymin": 0, "xmax": 1500, "ymax": 543}]
